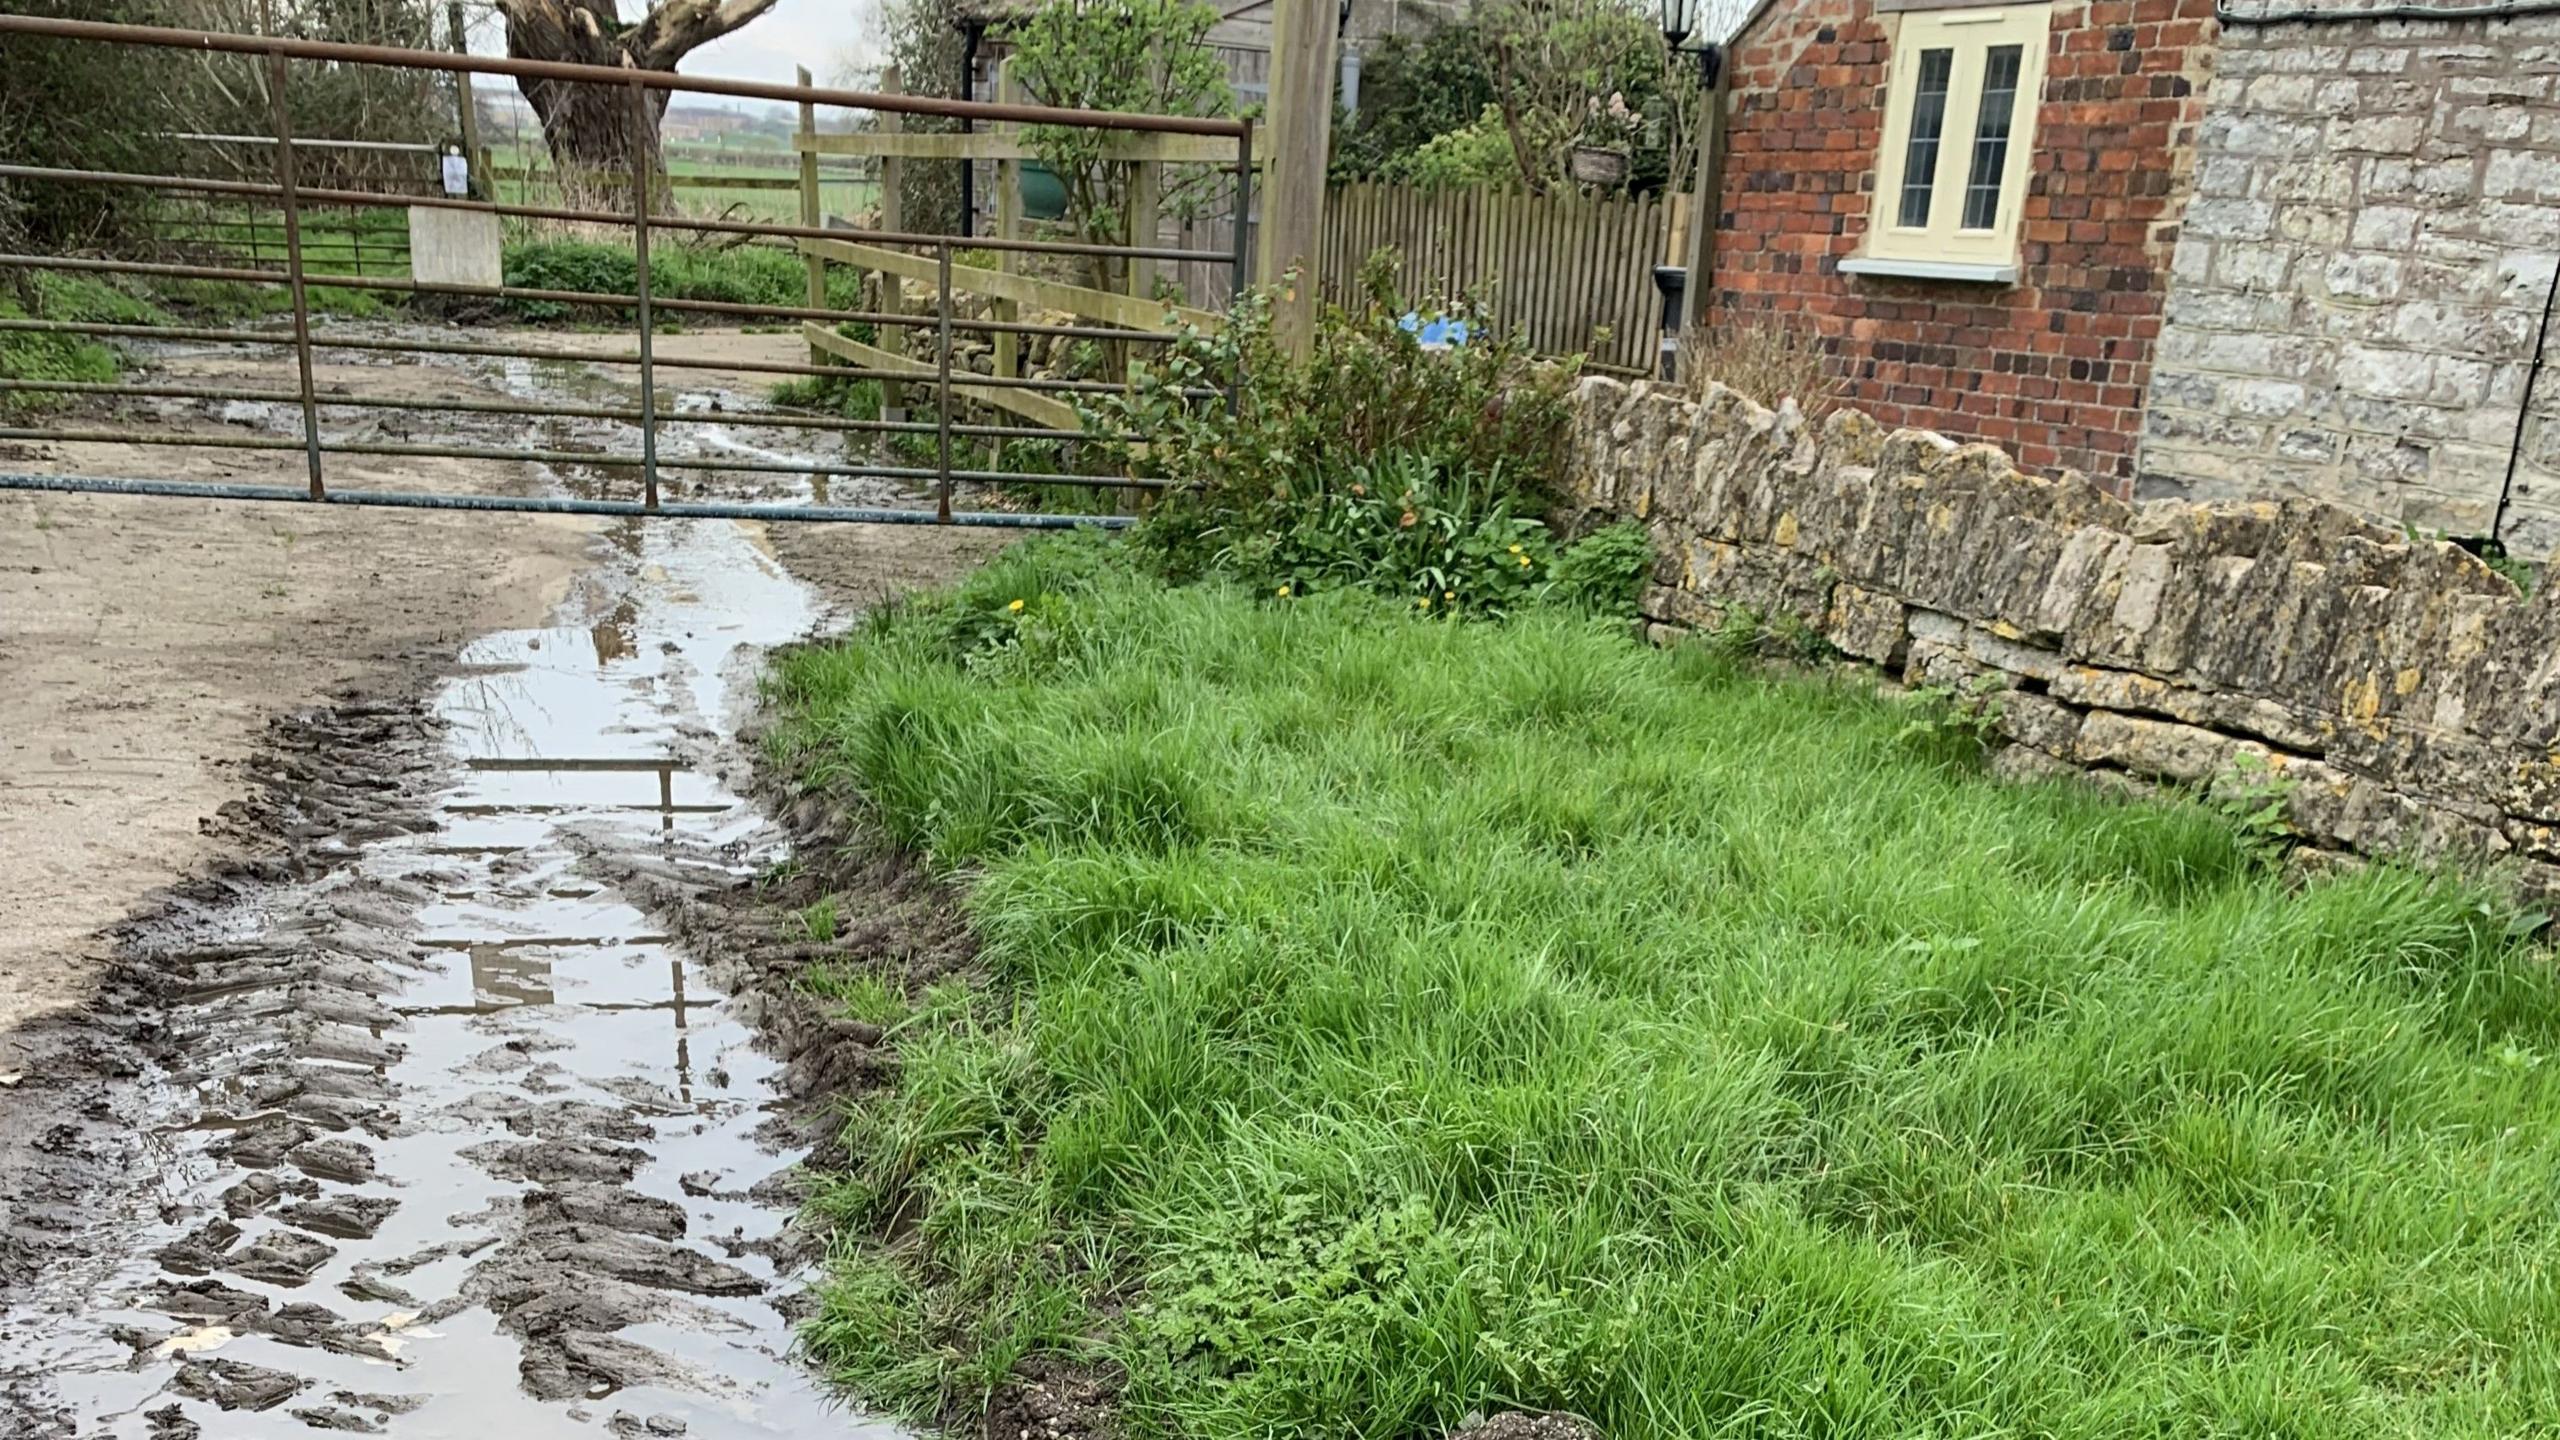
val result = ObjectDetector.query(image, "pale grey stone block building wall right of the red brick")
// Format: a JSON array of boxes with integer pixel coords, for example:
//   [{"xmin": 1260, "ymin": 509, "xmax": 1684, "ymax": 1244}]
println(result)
[{"xmin": 2135, "ymin": 15, "xmax": 2560, "ymax": 561}]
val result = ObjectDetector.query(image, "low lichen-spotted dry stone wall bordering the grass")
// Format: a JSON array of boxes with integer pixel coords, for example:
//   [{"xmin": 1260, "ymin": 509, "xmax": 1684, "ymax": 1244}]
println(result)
[{"xmin": 1567, "ymin": 377, "xmax": 2560, "ymax": 899}]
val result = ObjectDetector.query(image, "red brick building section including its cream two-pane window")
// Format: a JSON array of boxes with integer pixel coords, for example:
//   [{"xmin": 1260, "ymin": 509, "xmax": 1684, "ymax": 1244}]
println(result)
[{"xmin": 1708, "ymin": 0, "xmax": 2214, "ymax": 489}]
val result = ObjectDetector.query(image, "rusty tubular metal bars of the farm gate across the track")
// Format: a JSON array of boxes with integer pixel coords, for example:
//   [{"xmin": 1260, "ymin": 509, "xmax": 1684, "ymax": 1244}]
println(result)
[{"xmin": 0, "ymin": 15, "xmax": 1252, "ymax": 525}]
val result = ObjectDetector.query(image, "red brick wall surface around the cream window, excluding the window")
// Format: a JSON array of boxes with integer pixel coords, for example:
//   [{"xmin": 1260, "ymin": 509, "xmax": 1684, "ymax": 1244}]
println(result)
[{"xmin": 1713, "ymin": 0, "xmax": 2217, "ymax": 489}]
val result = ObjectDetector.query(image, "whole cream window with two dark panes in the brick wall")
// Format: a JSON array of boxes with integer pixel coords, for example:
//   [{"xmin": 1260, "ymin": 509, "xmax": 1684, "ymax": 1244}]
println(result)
[{"xmin": 1843, "ymin": 5, "xmax": 2053, "ymax": 279}]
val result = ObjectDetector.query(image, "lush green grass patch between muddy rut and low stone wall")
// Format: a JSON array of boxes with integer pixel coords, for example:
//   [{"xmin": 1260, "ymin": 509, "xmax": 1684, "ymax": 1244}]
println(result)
[{"xmin": 773, "ymin": 543, "xmax": 2560, "ymax": 1440}]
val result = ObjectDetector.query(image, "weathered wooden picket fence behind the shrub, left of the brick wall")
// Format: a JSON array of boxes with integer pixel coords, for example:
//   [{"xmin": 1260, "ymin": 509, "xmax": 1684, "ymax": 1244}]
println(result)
[{"xmin": 1318, "ymin": 182, "xmax": 1672, "ymax": 372}]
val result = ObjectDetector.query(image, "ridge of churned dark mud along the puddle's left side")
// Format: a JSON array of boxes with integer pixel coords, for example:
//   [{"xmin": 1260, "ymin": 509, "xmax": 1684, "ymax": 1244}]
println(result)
[{"xmin": 0, "ymin": 694, "xmax": 455, "ymax": 1437}]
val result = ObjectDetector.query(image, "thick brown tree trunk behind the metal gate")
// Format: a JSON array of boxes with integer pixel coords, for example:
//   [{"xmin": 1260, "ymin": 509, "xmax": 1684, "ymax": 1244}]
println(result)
[{"xmin": 497, "ymin": 0, "xmax": 776, "ymax": 197}]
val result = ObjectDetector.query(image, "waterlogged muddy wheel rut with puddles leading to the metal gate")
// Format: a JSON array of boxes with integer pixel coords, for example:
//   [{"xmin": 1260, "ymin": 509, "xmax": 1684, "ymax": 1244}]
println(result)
[{"xmin": 0, "ymin": 340, "xmax": 921, "ymax": 1440}]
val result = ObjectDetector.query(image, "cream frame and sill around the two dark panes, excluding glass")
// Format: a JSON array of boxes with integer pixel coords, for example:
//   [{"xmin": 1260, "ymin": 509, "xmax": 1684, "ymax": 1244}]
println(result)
[{"xmin": 1841, "ymin": 5, "xmax": 2053, "ymax": 282}]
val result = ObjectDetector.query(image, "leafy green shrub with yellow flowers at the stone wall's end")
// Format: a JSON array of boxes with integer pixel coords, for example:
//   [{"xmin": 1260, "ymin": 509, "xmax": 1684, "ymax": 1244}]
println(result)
[{"xmin": 1088, "ymin": 251, "xmax": 1651, "ymax": 618}]
